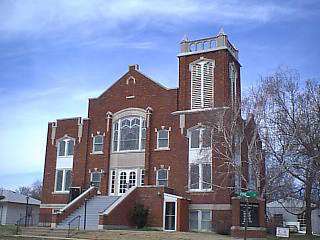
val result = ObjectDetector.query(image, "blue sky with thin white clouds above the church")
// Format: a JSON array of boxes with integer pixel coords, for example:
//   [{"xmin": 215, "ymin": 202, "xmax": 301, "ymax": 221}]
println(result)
[{"xmin": 0, "ymin": 0, "xmax": 320, "ymax": 189}]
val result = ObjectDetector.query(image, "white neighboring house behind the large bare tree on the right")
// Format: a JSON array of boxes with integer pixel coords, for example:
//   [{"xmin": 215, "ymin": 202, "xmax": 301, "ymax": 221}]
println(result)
[{"xmin": 267, "ymin": 198, "xmax": 320, "ymax": 234}]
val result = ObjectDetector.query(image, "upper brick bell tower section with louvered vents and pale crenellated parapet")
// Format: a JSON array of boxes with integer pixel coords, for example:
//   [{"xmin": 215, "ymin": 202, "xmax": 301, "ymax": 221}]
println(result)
[{"xmin": 178, "ymin": 29, "xmax": 240, "ymax": 111}]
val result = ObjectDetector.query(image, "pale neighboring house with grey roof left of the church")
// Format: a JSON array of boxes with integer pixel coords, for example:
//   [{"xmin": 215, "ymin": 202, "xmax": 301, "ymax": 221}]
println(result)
[{"xmin": 0, "ymin": 189, "xmax": 41, "ymax": 225}]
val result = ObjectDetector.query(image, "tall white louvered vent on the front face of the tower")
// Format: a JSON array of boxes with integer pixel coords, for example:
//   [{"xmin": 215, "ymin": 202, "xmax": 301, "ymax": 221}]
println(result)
[{"xmin": 191, "ymin": 60, "xmax": 214, "ymax": 109}]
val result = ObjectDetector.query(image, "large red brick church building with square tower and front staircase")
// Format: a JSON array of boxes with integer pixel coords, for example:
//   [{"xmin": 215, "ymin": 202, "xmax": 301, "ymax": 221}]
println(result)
[{"xmin": 40, "ymin": 31, "xmax": 265, "ymax": 237}]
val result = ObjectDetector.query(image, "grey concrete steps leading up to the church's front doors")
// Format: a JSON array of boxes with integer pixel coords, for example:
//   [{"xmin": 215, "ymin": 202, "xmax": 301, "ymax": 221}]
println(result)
[{"xmin": 57, "ymin": 196, "xmax": 119, "ymax": 230}]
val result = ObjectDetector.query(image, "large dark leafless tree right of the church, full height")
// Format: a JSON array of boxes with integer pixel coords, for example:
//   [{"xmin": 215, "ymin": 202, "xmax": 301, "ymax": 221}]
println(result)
[{"xmin": 244, "ymin": 68, "xmax": 320, "ymax": 235}]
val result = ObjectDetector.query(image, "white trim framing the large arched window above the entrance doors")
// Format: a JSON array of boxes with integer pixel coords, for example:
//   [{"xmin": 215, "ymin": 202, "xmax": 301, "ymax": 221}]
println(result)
[{"xmin": 112, "ymin": 115, "xmax": 146, "ymax": 153}]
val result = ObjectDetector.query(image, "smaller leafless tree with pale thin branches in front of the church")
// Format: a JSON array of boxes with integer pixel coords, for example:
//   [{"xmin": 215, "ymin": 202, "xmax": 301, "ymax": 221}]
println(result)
[{"xmin": 189, "ymin": 99, "xmax": 265, "ymax": 197}]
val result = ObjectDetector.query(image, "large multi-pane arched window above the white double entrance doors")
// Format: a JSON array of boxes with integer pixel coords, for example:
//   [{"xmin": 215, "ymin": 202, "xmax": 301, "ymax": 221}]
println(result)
[{"xmin": 113, "ymin": 116, "xmax": 146, "ymax": 152}]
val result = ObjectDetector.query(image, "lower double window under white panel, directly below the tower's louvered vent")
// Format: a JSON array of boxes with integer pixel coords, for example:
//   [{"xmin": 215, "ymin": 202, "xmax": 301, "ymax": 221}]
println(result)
[{"xmin": 189, "ymin": 163, "xmax": 212, "ymax": 191}]
